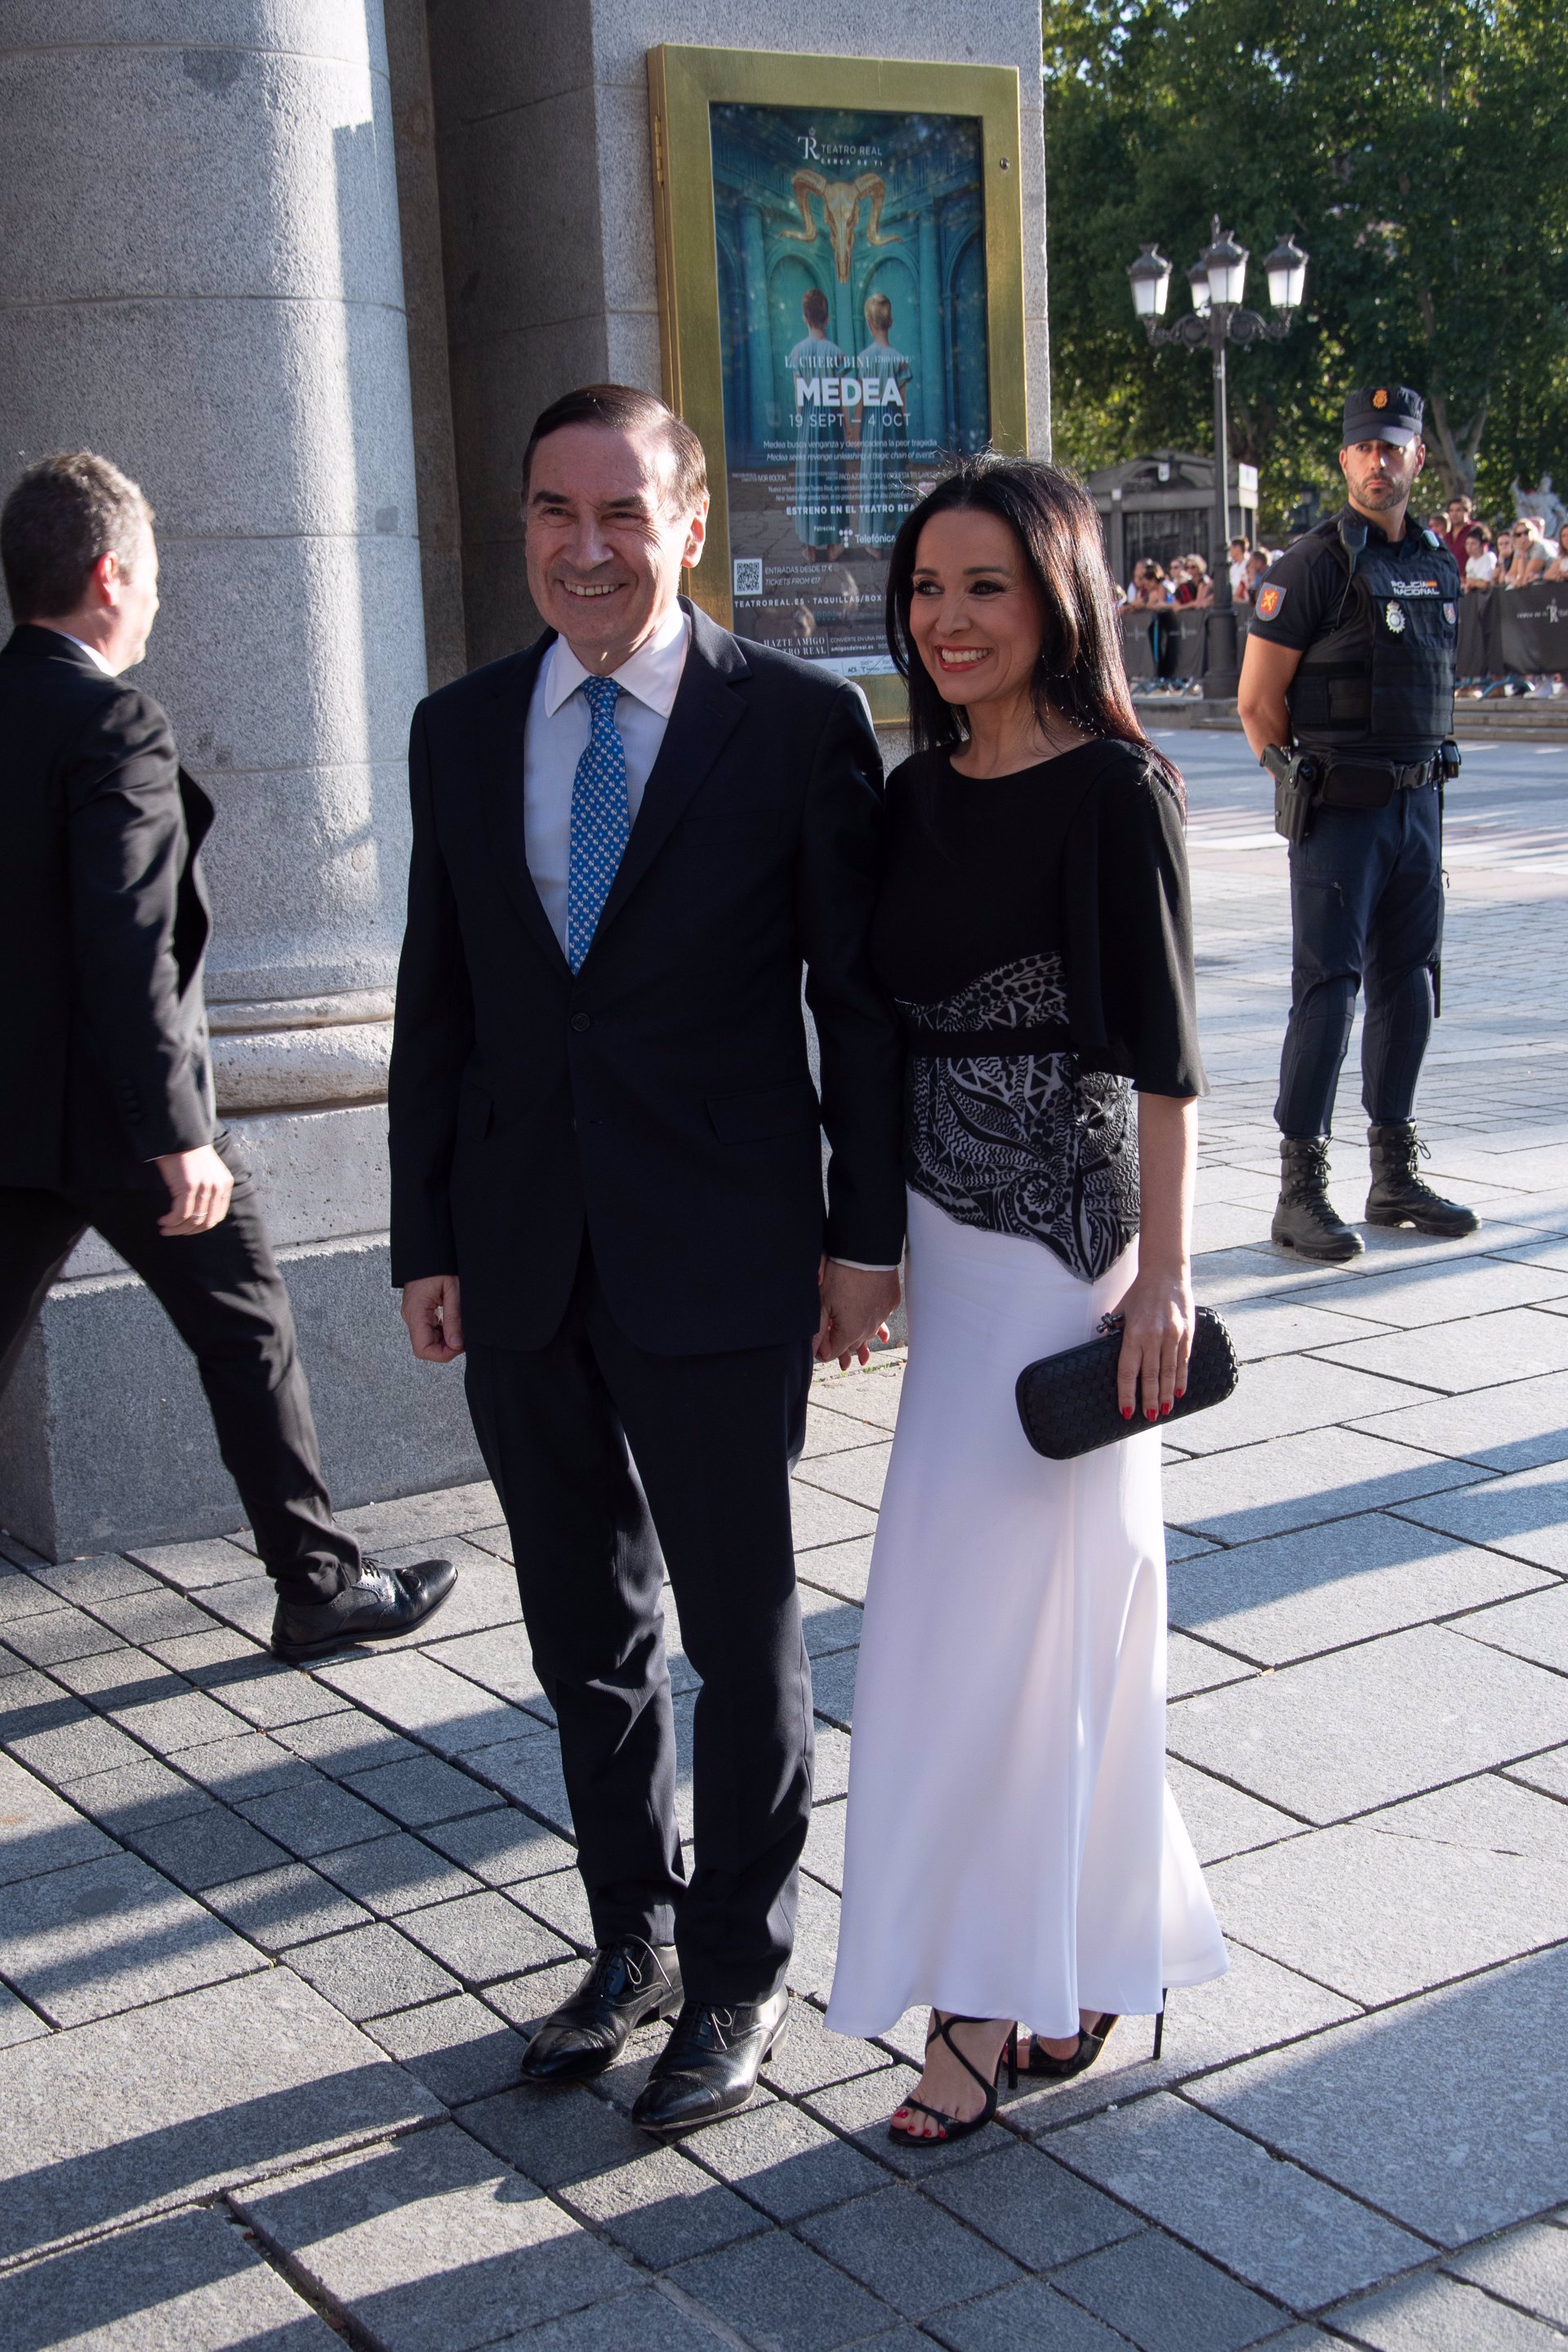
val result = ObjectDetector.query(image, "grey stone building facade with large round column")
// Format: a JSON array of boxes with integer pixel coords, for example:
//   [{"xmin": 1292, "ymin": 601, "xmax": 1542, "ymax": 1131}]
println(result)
[{"xmin": 0, "ymin": 0, "xmax": 1049, "ymax": 1557}]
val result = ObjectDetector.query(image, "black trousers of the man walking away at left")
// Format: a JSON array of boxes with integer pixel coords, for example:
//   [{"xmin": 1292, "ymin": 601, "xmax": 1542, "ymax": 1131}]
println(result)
[{"xmin": 0, "ymin": 1136, "xmax": 359, "ymax": 1601}]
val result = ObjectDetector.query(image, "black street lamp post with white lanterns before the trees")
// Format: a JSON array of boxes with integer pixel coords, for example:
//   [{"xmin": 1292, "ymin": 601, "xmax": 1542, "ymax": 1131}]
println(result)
[{"xmin": 1126, "ymin": 212, "xmax": 1309, "ymax": 694}]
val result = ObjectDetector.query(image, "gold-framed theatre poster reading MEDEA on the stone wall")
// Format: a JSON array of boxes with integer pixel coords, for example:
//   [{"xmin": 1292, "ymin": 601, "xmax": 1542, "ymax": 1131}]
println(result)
[{"xmin": 648, "ymin": 47, "xmax": 1025, "ymax": 719}]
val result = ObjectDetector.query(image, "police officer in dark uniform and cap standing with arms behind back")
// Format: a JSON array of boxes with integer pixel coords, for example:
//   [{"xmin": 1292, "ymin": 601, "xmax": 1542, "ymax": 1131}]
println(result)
[{"xmin": 1239, "ymin": 383, "xmax": 1479, "ymax": 1263}]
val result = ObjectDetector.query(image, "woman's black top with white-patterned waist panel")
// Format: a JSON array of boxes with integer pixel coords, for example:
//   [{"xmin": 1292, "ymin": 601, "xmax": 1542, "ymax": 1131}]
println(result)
[{"xmin": 872, "ymin": 743, "xmax": 1204, "ymax": 1282}]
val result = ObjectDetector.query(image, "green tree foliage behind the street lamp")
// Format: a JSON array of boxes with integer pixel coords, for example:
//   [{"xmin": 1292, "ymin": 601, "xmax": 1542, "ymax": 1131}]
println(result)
[{"xmin": 1044, "ymin": 0, "xmax": 1568, "ymax": 522}]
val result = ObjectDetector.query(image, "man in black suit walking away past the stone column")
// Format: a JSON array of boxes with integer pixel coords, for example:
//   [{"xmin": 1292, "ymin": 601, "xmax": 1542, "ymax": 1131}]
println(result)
[{"xmin": 0, "ymin": 452, "xmax": 456, "ymax": 1660}]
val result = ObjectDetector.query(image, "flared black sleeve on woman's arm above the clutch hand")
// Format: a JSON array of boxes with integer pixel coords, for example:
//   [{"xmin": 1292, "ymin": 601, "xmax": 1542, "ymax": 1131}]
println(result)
[{"xmin": 1062, "ymin": 743, "xmax": 1209, "ymax": 1096}]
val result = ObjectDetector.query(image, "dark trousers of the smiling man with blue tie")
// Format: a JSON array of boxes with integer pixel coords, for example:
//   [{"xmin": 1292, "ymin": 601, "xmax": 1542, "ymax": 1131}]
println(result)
[{"xmin": 468, "ymin": 1249, "xmax": 811, "ymax": 2002}]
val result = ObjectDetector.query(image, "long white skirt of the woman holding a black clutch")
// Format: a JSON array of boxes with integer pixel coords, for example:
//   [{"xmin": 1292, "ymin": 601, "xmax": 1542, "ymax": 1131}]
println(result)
[{"xmin": 827, "ymin": 1195, "xmax": 1227, "ymax": 2039}]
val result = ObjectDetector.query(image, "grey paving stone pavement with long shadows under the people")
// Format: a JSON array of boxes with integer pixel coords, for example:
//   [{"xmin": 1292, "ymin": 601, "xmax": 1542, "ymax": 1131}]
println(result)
[{"xmin": 0, "ymin": 734, "xmax": 1568, "ymax": 2352}]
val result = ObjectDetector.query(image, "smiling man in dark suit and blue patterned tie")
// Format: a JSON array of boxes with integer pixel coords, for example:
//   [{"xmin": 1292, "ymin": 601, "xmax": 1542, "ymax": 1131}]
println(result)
[{"xmin": 390, "ymin": 385, "xmax": 902, "ymax": 2131}]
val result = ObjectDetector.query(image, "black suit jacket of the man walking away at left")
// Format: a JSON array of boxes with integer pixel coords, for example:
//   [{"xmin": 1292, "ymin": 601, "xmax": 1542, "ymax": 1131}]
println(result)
[{"xmin": 0, "ymin": 626, "xmax": 216, "ymax": 1190}]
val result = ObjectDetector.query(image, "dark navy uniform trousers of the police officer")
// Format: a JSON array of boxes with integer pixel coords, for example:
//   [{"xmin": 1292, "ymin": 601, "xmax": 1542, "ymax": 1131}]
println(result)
[{"xmin": 1274, "ymin": 783, "xmax": 1443, "ymax": 1136}]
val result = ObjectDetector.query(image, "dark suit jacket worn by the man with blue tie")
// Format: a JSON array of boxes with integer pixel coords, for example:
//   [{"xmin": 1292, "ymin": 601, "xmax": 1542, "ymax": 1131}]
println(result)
[{"xmin": 390, "ymin": 607, "xmax": 902, "ymax": 1355}]
